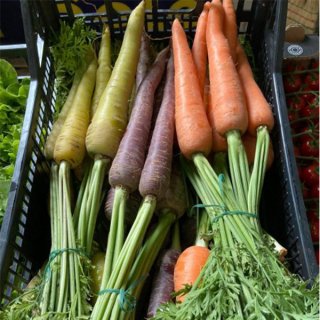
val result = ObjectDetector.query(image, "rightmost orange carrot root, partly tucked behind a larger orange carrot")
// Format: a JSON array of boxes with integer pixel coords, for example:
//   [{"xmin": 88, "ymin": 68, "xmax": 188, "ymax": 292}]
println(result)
[{"xmin": 237, "ymin": 44, "xmax": 274, "ymax": 135}]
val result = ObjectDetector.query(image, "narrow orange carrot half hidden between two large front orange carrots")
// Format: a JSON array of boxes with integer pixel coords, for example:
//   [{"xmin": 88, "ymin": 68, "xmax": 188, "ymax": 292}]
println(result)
[{"xmin": 192, "ymin": 1, "xmax": 210, "ymax": 97}]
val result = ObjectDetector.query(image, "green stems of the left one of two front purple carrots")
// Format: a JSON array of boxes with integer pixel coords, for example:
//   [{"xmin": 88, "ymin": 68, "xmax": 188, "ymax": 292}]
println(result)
[{"xmin": 101, "ymin": 187, "xmax": 128, "ymax": 289}]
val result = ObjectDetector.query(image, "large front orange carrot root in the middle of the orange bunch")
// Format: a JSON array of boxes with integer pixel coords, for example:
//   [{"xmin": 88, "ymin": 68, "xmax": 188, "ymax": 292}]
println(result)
[{"xmin": 206, "ymin": 0, "xmax": 248, "ymax": 136}]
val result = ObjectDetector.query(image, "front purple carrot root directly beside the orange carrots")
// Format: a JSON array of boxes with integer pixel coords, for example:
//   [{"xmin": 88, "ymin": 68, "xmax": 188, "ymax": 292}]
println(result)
[{"xmin": 139, "ymin": 56, "xmax": 174, "ymax": 199}]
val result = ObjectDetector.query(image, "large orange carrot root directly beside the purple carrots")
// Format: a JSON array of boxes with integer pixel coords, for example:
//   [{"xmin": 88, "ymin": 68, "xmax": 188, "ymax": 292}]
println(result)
[{"xmin": 172, "ymin": 19, "xmax": 212, "ymax": 159}]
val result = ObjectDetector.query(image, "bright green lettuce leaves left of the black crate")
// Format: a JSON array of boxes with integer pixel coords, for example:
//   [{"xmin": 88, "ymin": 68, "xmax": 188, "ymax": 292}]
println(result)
[{"xmin": 0, "ymin": 59, "xmax": 30, "ymax": 225}]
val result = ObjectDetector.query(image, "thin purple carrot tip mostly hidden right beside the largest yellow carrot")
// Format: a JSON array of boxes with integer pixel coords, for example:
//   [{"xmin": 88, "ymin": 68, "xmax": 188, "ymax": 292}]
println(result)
[{"xmin": 136, "ymin": 31, "xmax": 151, "ymax": 92}]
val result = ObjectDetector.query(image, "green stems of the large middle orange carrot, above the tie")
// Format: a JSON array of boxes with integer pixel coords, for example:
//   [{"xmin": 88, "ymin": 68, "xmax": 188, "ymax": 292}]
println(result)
[{"xmin": 227, "ymin": 130, "xmax": 250, "ymax": 211}]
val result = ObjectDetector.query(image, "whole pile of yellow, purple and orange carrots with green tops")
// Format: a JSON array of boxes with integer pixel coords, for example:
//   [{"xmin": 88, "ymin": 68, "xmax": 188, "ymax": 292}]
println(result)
[{"xmin": 2, "ymin": 0, "xmax": 318, "ymax": 320}]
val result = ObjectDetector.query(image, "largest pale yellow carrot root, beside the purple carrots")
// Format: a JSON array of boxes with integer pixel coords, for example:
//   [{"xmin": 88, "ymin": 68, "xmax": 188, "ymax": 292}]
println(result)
[{"xmin": 86, "ymin": 1, "xmax": 144, "ymax": 158}]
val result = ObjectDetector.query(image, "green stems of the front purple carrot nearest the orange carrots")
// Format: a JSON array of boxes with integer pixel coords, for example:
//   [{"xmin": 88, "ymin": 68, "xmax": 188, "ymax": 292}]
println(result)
[{"xmin": 91, "ymin": 196, "xmax": 156, "ymax": 320}]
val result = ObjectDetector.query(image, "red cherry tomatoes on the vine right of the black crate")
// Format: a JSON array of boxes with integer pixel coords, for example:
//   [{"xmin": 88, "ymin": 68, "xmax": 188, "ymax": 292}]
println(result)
[{"xmin": 283, "ymin": 58, "xmax": 319, "ymax": 264}]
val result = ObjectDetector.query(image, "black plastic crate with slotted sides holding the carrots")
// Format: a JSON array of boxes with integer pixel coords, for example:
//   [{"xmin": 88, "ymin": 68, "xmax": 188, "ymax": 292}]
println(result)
[{"xmin": 0, "ymin": 0, "xmax": 317, "ymax": 305}]
